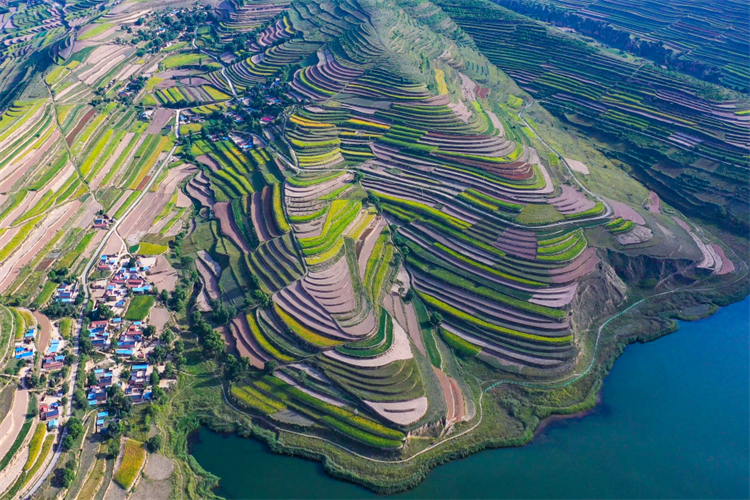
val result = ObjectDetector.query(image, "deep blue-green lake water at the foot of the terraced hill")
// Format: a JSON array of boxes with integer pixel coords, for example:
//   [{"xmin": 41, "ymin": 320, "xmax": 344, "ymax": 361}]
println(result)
[{"xmin": 193, "ymin": 298, "xmax": 750, "ymax": 500}]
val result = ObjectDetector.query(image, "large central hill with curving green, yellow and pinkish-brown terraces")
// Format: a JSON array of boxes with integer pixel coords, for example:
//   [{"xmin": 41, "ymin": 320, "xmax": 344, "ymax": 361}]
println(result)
[{"xmin": 154, "ymin": 0, "xmax": 743, "ymax": 460}]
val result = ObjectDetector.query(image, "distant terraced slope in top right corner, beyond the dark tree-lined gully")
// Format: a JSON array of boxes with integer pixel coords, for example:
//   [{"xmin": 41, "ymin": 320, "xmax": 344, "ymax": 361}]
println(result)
[{"xmin": 497, "ymin": 0, "xmax": 750, "ymax": 92}]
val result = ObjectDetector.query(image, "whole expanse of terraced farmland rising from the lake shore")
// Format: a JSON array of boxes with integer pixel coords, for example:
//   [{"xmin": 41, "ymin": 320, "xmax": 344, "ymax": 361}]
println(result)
[{"xmin": 0, "ymin": 0, "xmax": 750, "ymax": 498}]
